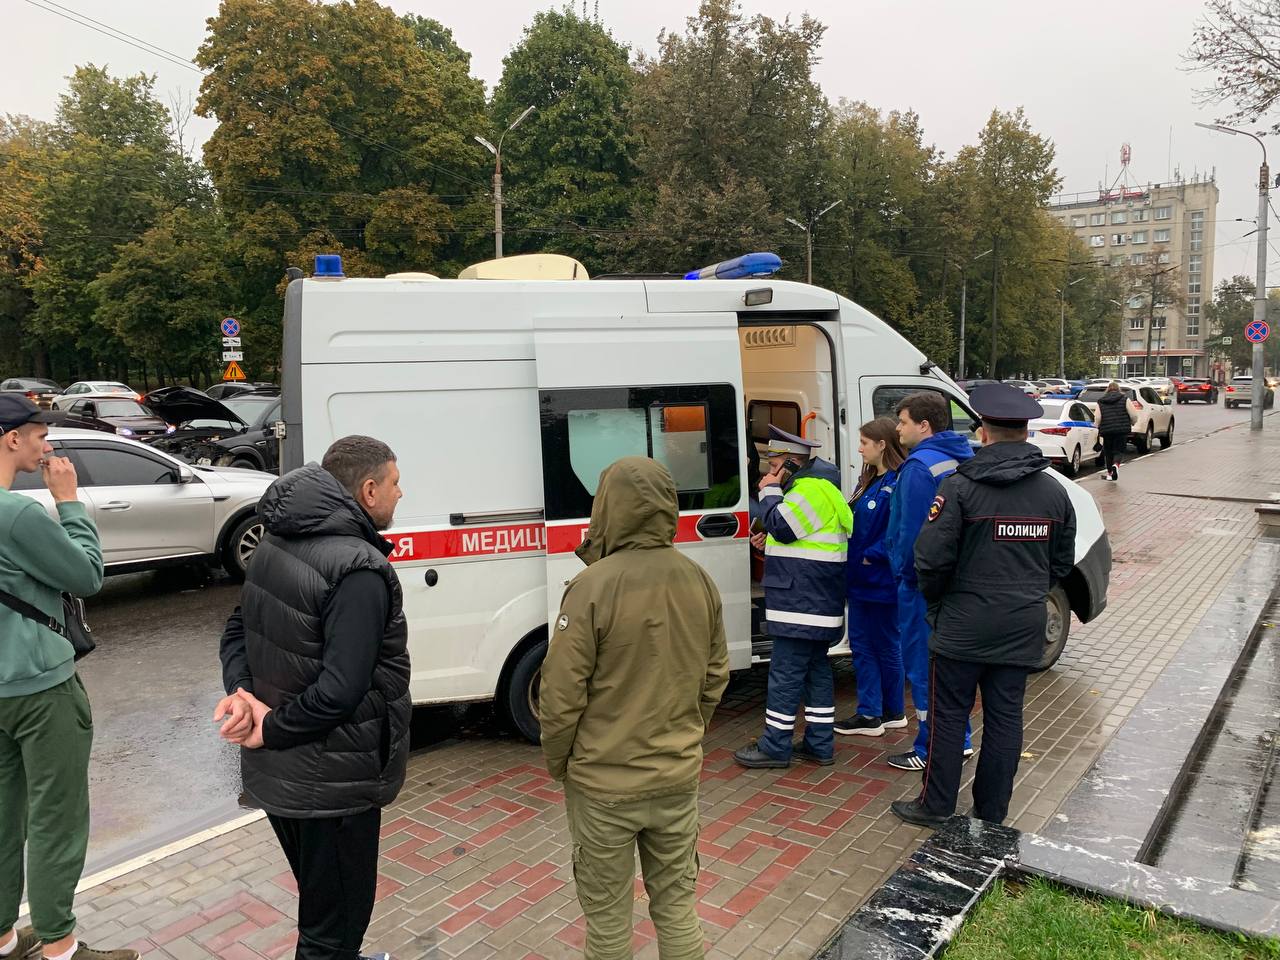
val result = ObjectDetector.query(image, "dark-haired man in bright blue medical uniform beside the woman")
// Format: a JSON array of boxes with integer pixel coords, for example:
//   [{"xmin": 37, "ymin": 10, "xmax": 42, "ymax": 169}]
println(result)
[{"xmin": 884, "ymin": 390, "xmax": 973, "ymax": 771}]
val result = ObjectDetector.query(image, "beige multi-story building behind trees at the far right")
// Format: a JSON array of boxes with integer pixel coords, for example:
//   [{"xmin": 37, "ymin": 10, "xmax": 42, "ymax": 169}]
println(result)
[{"xmin": 1050, "ymin": 177, "xmax": 1217, "ymax": 376}]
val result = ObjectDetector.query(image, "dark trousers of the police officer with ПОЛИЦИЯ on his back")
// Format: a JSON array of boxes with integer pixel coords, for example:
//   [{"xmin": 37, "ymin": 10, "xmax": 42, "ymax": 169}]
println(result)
[{"xmin": 920, "ymin": 654, "xmax": 1028, "ymax": 823}]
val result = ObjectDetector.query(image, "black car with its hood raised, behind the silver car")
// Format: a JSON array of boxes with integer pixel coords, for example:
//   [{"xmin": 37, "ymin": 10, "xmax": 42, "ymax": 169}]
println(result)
[{"xmin": 145, "ymin": 387, "xmax": 280, "ymax": 474}]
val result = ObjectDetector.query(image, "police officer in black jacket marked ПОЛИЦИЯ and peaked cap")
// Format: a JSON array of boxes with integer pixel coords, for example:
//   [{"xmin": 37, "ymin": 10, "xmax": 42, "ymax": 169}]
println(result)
[{"xmin": 892, "ymin": 384, "xmax": 1075, "ymax": 827}]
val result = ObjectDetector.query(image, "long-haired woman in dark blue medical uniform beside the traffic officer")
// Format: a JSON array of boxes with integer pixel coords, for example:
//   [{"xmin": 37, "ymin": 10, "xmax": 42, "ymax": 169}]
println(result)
[{"xmin": 836, "ymin": 417, "xmax": 906, "ymax": 737}]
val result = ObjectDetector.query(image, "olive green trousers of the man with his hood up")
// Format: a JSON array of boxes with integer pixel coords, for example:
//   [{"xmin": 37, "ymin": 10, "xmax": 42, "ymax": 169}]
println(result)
[{"xmin": 564, "ymin": 783, "xmax": 703, "ymax": 960}]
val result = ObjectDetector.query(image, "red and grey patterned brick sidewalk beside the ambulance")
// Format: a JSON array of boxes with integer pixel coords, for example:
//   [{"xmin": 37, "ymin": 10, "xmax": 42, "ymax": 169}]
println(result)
[{"xmin": 40, "ymin": 419, "xmax": 1280, "ymax": 960}]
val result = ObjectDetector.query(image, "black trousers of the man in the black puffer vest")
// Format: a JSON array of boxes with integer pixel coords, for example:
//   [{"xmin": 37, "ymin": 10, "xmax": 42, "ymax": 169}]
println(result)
[{"xmin": 268, "ymin": 809, "xmax": 383, "ymax": 960}]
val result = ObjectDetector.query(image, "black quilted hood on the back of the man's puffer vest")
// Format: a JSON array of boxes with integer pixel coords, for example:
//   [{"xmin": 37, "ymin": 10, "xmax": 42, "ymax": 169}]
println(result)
[{"xmin": 257, "ymin": 463, "xmax": 392, "ymax": 556}]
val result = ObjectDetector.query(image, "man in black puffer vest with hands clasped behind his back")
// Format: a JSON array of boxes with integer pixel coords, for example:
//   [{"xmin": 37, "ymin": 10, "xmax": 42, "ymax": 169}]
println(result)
[{"xmin": 214, "ymin": 436, "xmax": 411, "ymax": 960}]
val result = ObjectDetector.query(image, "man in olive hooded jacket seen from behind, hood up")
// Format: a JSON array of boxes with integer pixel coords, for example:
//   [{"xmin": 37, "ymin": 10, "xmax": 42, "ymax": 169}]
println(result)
[{"xmin": 539, "ymin": 457, "xmax": 728, "ymax": 960}]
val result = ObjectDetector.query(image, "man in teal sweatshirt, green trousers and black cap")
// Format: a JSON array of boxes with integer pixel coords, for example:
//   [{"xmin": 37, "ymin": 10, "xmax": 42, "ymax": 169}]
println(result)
[{"xmin": 0, "ymin": 394, "xmax": 129, "ymax": 960}]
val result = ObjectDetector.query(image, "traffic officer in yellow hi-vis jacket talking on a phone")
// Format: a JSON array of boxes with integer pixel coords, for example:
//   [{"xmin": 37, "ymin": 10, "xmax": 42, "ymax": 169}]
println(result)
[{"xmin": 733, "ymin": 426, "xmax": 854, "ymax": 767}]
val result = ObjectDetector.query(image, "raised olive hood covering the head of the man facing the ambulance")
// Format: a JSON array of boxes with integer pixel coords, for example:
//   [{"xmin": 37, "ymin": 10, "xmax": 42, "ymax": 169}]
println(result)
[{"xmin": 576, "ymin": 457, "xmax": 680, "ymax": 566}]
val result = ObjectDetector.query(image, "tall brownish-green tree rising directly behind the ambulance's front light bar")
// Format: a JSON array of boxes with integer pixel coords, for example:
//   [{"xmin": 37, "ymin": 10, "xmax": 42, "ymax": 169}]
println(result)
[{"xmin": 628, "ymin": 0, "xmax": 824, "ymax": 270}]
